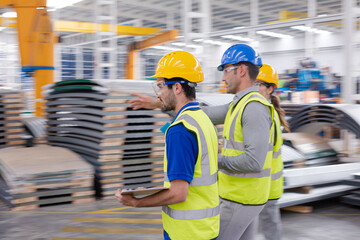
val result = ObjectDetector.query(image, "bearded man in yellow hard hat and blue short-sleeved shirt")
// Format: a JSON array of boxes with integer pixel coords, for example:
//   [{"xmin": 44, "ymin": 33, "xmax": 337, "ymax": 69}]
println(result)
[{"xmin": 116, "ymin": 51, "xmax": 220, "ymax": 240}]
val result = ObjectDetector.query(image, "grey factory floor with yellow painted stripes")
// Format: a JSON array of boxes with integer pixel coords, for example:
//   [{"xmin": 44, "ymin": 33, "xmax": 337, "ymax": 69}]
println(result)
[{"xmin": 0, "ymin": 199, "xmax": 360, "ymax": 240}]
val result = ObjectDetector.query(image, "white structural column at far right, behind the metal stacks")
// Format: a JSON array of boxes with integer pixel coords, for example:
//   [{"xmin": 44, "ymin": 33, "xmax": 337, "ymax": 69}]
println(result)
[{"xmin": 341, "ymin": 0, "xmax": 360, "ymax": 103}]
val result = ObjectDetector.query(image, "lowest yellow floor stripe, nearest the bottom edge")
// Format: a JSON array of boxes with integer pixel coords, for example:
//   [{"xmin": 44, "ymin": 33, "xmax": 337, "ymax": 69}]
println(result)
[{"xmin": 61, "ymin": 227, "xmax": 163, "ymax": 234}]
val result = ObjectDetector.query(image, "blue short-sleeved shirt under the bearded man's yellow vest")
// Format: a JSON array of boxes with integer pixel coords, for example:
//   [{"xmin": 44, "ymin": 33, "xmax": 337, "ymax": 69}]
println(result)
[{"xmin": 164, "ymin": 102, "xmax": 200, "ymax": 240}]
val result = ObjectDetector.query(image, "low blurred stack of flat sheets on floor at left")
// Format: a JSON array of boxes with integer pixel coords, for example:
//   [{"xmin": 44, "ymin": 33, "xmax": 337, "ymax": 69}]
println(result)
[{"xmin": 0, "ymin": 146, "xmax": 95, "ymax": 210}]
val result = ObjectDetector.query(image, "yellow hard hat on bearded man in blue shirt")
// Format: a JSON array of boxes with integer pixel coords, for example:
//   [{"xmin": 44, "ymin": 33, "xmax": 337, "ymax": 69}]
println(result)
[{"xmin": 152, "ymin": 51, "xmax": 204, "ymax": 83}]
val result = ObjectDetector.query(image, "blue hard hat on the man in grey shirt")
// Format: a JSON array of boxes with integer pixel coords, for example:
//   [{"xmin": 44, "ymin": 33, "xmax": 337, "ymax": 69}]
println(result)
[{"xmin": 218, "ymin": 44, "xmax": 262, "ymax": 71}]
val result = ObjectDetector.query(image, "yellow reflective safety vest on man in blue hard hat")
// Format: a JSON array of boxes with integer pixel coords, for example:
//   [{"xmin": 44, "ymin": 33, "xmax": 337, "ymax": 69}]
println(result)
[{"xmin": 219, "ymin": 92, "xmax": 274, "ymax": 205}]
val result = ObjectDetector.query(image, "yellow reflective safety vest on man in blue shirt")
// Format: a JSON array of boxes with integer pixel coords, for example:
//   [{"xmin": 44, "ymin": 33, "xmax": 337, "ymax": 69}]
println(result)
[{"xmin": 162, "ymin": 109, "xmax": 220, "ymax": 240}]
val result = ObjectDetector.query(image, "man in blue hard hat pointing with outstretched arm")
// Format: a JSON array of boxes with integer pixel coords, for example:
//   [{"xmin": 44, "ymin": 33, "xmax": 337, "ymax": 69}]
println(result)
[{"xmin": 130, "ymin": 44, "xmax": 274, "ymax": 240}]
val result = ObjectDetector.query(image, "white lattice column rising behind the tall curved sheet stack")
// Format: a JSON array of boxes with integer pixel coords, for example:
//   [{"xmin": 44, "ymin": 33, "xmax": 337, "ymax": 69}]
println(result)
[{"xmin": 94, "ymin": 0, "xmax": 117, "ymax": 79}]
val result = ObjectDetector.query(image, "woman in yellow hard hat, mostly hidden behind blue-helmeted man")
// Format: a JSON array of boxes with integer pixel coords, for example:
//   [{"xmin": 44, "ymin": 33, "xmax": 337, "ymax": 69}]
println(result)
[{"xmin": 256, "ymin": 64, "xmax": 290, "ymax": 240}]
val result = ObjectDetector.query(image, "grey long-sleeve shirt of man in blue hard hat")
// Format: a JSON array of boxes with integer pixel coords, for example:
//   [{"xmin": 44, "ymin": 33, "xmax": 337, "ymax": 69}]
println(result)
[{"xmin": 201, "ymin": 87, "xmax": 272, "ymax": 173}]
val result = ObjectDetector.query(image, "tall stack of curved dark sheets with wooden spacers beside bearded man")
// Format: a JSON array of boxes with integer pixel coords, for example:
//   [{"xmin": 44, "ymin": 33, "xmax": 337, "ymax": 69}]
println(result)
[{"xmin": 46, "ymin": 80, "xmax": 171, "ymax": 197}]
